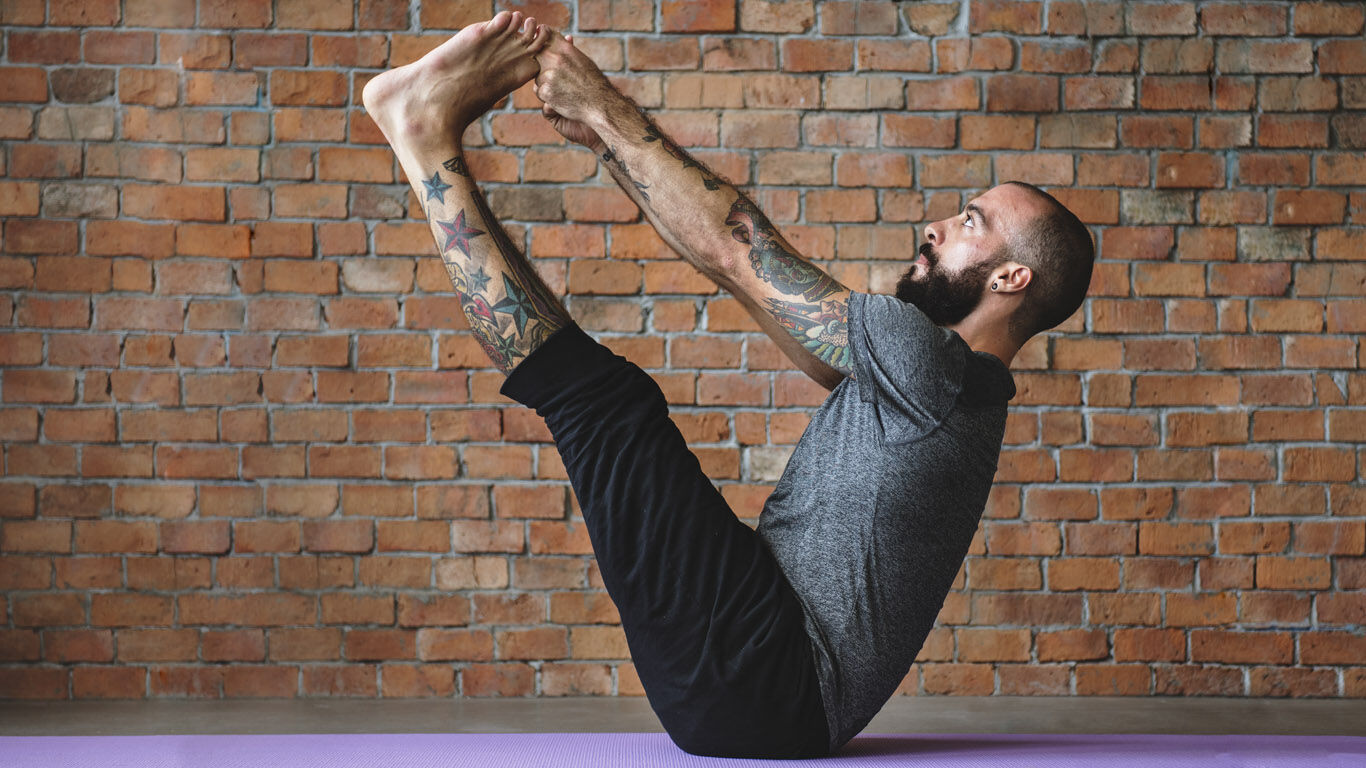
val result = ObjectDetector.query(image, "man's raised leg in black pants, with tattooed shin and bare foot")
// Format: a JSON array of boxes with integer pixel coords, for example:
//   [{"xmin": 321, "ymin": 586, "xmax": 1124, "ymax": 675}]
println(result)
[{"xmin": 365, "ymin": 14, "xmax": 828, "ymax": 757}]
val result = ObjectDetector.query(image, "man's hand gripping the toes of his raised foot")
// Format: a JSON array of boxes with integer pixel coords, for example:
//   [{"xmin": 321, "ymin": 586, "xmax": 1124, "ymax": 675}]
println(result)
[{"xmin": 535, "ymin": 31, "xmax": 617, "ymax": 154}]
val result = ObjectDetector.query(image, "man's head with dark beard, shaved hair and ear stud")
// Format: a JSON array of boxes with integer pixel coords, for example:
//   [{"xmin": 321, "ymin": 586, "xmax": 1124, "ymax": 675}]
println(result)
[{"xmin": 896, "ymin": 182, "xmax": 1094, "ymax": 343}]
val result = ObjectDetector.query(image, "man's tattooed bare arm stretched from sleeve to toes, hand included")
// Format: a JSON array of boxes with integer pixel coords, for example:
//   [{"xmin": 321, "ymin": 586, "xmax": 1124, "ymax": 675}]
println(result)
[{"xmin": 537, "ymin": 37, "xmax": 852, "ymax": 388}]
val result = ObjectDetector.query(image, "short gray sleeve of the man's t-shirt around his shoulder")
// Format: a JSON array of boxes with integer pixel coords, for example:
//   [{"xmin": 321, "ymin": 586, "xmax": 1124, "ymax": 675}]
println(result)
[{"xmin": 850, "ymin": 291, "xmax": 964, "ymax": 443}]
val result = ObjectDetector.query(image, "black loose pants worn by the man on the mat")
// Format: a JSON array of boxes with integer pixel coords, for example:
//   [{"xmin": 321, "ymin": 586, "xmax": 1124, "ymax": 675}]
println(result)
[{"xmin": 503, "ymin": 325, "xmax": 829, "ymax": 757}]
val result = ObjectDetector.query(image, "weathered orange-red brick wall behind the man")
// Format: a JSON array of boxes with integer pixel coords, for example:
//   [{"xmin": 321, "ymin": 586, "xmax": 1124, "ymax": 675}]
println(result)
[{"xmin": 0, "ymin": 0, "xmax": 1366, "ymax": 698}]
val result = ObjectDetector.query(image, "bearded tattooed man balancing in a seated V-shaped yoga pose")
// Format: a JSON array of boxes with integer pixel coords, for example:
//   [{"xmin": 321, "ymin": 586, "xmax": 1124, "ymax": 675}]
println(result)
[{"xmin": 363, "ymin": 12, "xmax": 1091, "ymax": 757}]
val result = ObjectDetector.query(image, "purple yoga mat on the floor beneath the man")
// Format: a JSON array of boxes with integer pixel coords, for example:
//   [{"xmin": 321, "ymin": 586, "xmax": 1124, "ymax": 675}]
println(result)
[{"xmin": 0, "ymin": 732, "xmax": 1366, "ymax": 768}]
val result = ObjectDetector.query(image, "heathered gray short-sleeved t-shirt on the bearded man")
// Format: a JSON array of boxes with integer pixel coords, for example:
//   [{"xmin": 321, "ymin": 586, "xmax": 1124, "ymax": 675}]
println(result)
[{"xmin": 758, "ymin": 292, "xmax": 1015, "ymax": 749}]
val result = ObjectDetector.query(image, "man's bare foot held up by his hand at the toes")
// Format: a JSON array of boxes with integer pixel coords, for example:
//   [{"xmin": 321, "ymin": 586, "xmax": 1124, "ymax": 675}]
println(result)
[{"xmin": 361, "ymin": 11, "xmax": 550, "ymax": 150}]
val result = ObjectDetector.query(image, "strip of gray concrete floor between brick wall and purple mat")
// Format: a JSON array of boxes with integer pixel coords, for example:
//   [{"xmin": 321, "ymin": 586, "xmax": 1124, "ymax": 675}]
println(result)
[{"xmin": 0, "ymin": 697, "xmax": 1366, "ymax": 737}]
